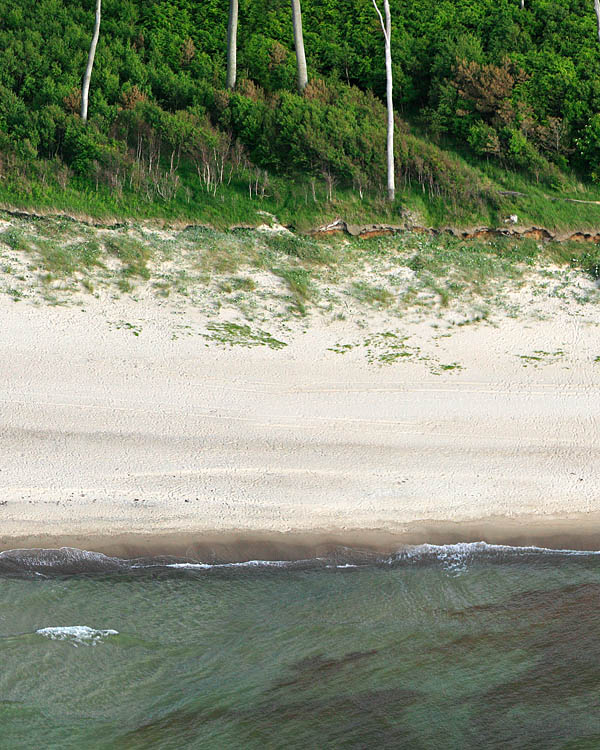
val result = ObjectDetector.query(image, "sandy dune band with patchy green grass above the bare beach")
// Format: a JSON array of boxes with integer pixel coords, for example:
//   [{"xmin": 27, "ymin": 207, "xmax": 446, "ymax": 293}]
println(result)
[{"xmin": 0, "ymin": 209, "xmax": 600, "ymax": 321}]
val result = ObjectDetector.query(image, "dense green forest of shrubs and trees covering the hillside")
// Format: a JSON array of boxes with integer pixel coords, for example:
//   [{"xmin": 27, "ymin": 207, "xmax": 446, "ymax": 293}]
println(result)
[{"xmin": 0, "ymin": 0, "xmax": 600, "ymax": 223}]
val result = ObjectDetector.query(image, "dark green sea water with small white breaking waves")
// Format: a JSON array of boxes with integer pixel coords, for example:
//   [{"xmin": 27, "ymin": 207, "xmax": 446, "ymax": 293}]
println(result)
[{"xmin": 0, "ymin": 545, "xmax": 600, "ymax": 750}]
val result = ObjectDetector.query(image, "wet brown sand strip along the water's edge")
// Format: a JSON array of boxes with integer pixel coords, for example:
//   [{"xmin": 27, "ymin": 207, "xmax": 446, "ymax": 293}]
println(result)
[{"xmin": 0, "ymin": 513, "xmax": 600, "ymax": 563}]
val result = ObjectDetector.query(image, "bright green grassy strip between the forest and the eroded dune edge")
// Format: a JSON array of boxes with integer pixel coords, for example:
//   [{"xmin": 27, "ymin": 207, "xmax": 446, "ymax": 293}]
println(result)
[{"xmin": 0, "ymin": 141, "xmax": 600, "ymax": 231}]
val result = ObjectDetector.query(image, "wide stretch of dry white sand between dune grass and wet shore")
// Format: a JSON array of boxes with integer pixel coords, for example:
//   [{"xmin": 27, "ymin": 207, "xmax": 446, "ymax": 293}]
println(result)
[{"xmin": 0, "ymin": 276, "xmax": 600, "ymax": 548}]
